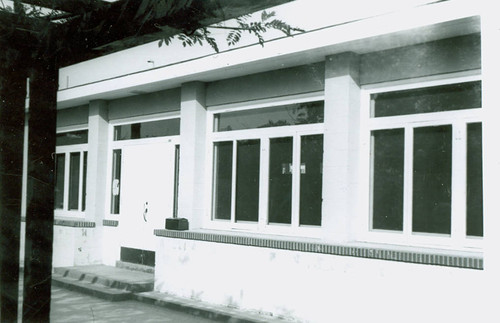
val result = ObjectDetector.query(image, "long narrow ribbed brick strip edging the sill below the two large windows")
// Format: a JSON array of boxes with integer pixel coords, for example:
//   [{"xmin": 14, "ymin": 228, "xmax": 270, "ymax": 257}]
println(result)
[{"xmin": 154, "ymin": 229, "xmax": 483, "ymax": 269}]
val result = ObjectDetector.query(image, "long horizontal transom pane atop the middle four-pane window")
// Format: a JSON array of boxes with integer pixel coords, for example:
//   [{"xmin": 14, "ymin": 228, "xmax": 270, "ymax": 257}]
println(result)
[{"xmin": 214, "ymin": 101, "xmax": 324, "ymax": 131}]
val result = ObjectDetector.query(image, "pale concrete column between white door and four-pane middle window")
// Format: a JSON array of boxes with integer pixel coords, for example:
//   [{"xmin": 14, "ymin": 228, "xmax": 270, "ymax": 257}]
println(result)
[{"xmin": 179, "ymin": 82, "xmax": 206, "ymax": 229}]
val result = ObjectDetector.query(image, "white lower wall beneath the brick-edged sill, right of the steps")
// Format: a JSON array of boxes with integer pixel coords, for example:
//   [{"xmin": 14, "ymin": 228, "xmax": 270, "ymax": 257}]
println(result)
[{"xmin": 155, "ymin": 237, "xmax": 486, "ymax": 323}]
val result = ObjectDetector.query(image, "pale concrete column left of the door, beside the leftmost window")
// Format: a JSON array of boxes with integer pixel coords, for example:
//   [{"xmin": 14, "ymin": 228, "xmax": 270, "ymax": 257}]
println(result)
[{"xmin": 85, "ymin": 100, "xmax": 108, "ymax": 226}]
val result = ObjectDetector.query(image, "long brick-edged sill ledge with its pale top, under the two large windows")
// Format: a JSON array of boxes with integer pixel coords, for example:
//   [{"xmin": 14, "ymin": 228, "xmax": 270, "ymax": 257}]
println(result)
[{"xmin": 154, "ymin": 229, "xmax": 483, "ymax": 270}]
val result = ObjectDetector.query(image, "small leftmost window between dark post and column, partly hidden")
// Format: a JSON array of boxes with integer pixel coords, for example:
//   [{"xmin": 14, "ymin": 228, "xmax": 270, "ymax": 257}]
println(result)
[{"xmin": 54, "ymin": 130, "xmax": 88, "ymax": 212}]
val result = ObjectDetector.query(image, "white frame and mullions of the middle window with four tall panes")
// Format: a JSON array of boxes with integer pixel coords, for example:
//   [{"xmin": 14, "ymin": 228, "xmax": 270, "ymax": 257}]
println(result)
[{"xmin": 204, "ymin": 92, "xmax": 326, "ymax": 237}]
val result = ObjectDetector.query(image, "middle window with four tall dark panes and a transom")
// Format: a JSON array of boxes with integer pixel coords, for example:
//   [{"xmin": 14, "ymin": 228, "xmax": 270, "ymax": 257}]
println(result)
[{"xmin": 212, "ymin": 101, "xmax": 324, "ymax": 231}]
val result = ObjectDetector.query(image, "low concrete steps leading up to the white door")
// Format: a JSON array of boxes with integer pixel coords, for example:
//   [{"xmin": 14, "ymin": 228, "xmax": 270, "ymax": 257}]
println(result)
[{"xmin": 52, "ymin": 265, "xmax": 154, "ymax": 301}]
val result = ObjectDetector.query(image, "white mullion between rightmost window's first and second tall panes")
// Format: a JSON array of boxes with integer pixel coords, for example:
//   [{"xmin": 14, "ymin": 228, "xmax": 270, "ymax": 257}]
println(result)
[{"xmin": 403, "ymin": 126, "xmax": 413, "ymax": 236}]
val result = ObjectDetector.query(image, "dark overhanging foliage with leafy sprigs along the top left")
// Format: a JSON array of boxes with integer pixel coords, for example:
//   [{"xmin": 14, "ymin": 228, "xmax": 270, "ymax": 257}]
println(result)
[{"xmin": 0, "ymin": 0, "xmax": 302, "ymax": 63}]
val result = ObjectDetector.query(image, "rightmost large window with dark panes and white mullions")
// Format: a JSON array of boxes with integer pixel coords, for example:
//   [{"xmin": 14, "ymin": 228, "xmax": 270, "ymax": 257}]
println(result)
[{"xmin": 368, "ymin": 81, "xmax": 483, "ymax": 244}]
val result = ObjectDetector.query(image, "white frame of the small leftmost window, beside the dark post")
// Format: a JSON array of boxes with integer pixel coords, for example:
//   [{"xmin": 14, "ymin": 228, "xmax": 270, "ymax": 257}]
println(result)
[{"xmin": 54, "ymin": 126, "xmax": 88, "ymax": 218}]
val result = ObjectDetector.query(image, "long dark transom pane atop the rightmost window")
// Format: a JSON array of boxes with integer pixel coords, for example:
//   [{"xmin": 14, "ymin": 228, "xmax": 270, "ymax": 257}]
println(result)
[{"xmin": 372, "ymin": 81, "xmax": 481, "ymax": 117}]
